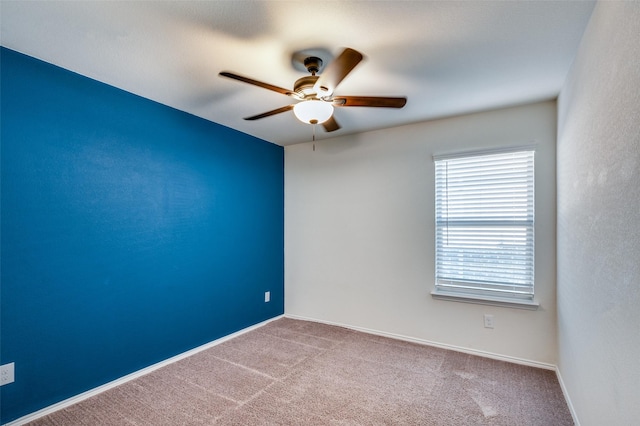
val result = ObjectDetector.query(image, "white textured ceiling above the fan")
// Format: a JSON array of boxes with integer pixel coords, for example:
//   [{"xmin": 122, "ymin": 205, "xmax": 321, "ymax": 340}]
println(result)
[{"xmin": 0, "ymin": 0, "xmax": 594, "ymax": 145}]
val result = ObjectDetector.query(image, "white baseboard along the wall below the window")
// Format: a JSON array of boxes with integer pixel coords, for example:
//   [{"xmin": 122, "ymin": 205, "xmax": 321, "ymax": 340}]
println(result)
[{"xmin": 284, "ymin": 313, "xmax": 556, "ymax": 371}]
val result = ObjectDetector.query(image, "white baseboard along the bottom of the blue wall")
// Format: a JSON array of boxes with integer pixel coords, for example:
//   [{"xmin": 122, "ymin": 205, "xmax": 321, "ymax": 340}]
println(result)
[{"xmin": 3, "ymin": 315, "xmax": 284, "ymax": 426}]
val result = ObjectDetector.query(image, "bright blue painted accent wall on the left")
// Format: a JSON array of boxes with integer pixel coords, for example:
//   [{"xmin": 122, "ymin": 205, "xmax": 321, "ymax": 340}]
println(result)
[{"xmin": 0, "ymin": 48, "xmax": 284, "ymax": 423}]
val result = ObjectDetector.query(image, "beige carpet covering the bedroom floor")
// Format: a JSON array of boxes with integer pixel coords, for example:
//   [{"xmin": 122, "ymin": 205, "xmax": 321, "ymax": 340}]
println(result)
[{"xmin": 30, "ymin": 318, "xmax": 573, "ymax": 426}]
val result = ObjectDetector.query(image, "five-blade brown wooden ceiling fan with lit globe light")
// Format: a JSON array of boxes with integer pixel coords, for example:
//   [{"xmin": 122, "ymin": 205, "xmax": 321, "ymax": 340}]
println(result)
[{"xmin": 219, "ymin": 48, "xmax": 407, "ymax": 132}]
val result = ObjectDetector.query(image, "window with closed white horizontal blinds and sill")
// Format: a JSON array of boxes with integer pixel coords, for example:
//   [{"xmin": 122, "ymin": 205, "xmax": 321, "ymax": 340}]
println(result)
[{"xmin": 432, "ymin": 150, "xmax": 537, "ymax": 306}]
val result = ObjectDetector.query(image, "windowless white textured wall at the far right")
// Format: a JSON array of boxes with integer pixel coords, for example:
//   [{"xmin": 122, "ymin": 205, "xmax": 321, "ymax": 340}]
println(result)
[{"xmin": 558, "ymin": 2, "xmax": 640, "ymax": 426}]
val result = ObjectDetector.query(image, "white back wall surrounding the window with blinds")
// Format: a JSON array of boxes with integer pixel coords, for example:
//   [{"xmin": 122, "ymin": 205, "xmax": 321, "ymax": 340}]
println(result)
[{"xmin": 285, "ymin": 99, "xmax": 557, "ymax": 365}]
